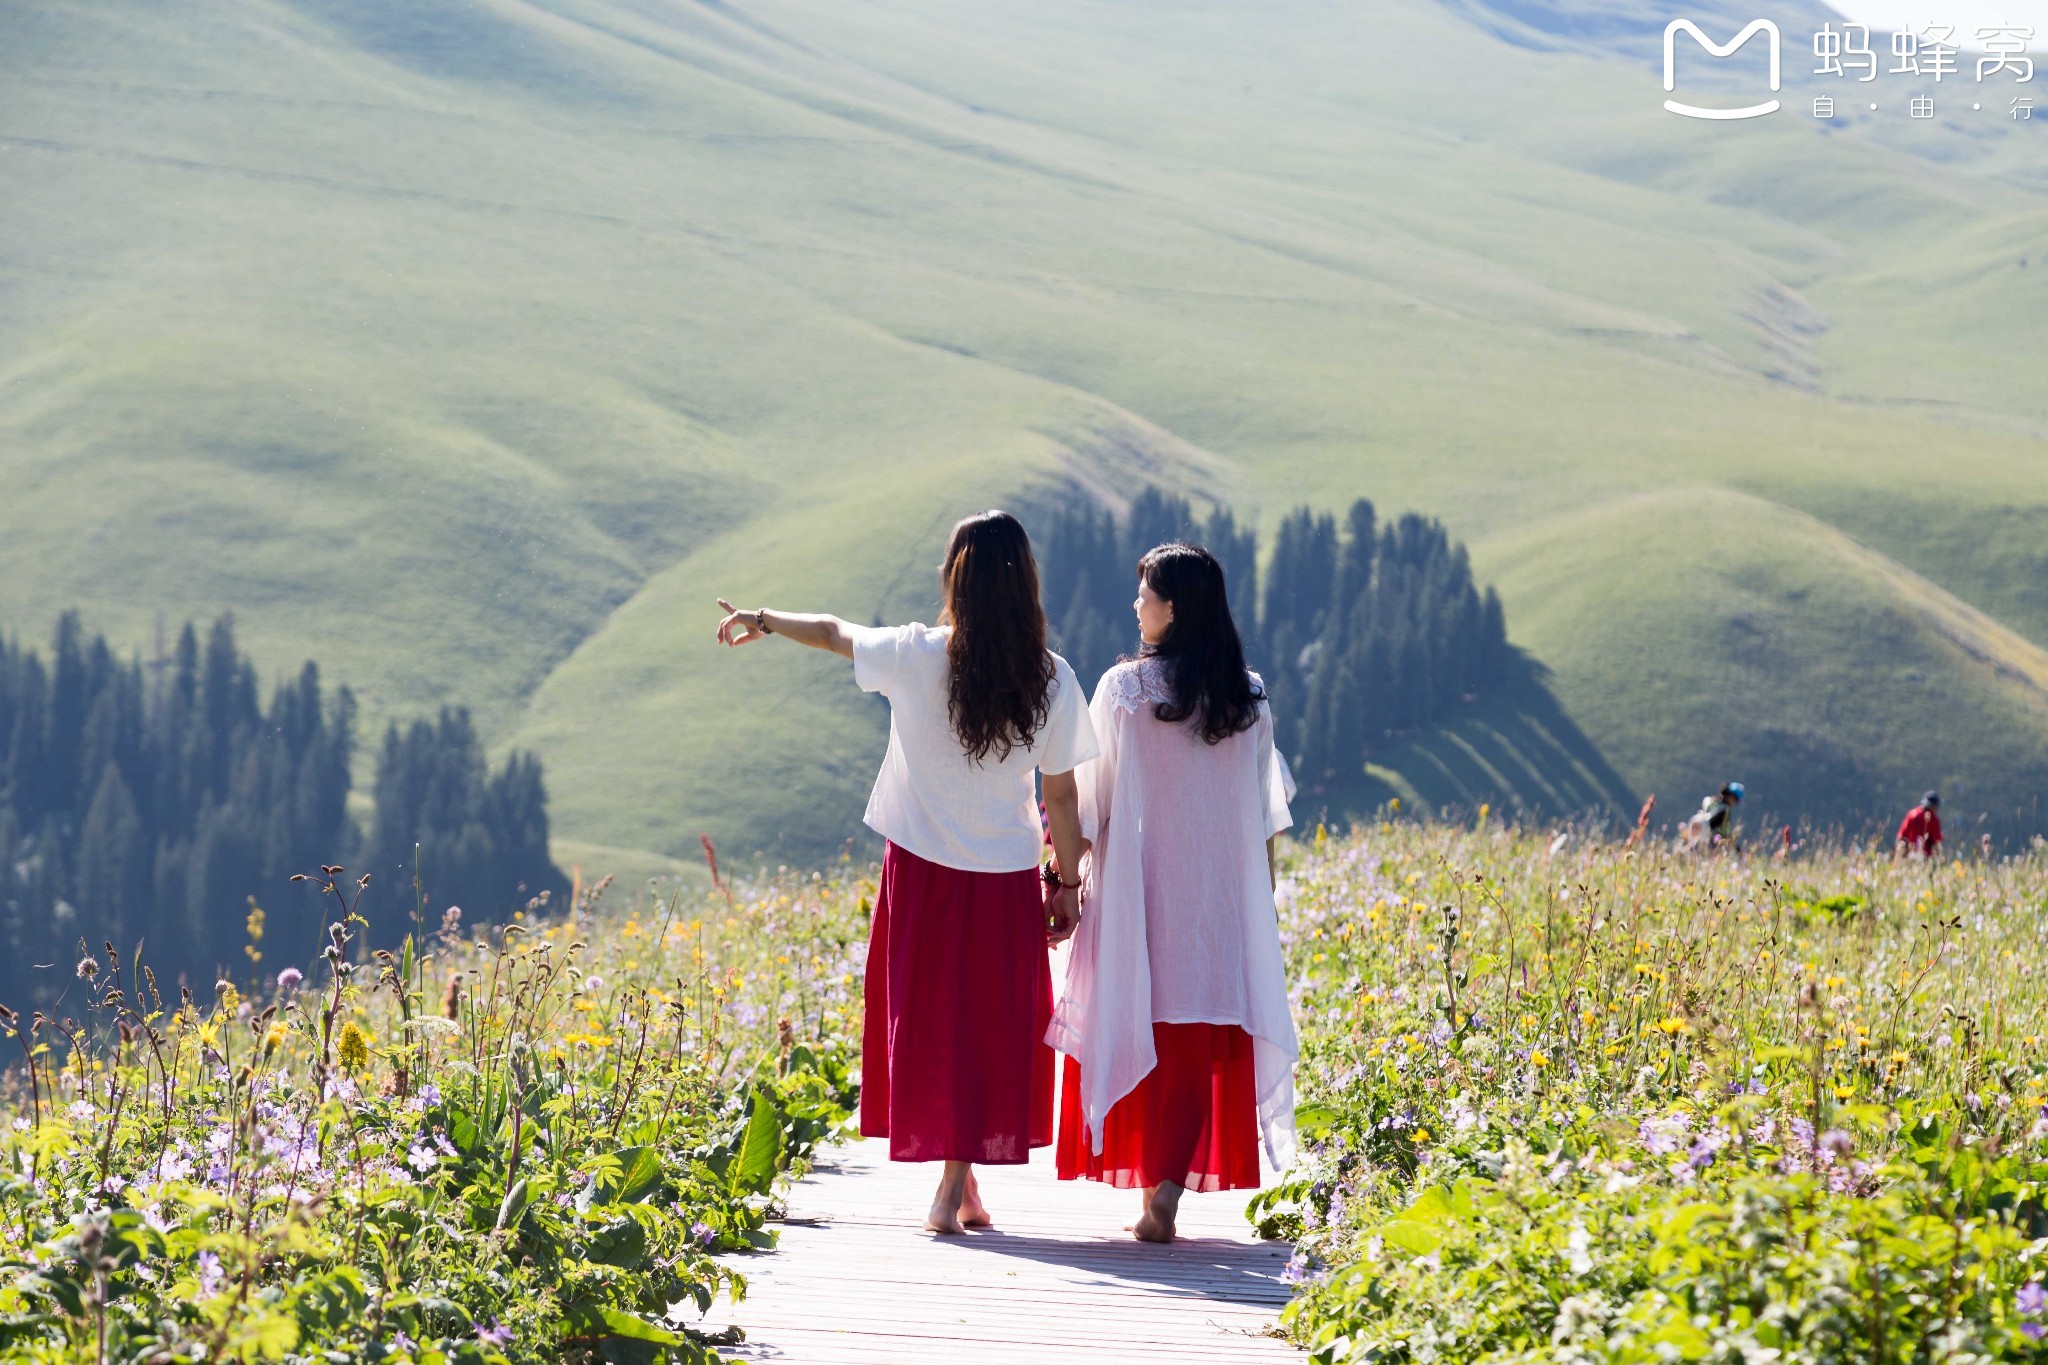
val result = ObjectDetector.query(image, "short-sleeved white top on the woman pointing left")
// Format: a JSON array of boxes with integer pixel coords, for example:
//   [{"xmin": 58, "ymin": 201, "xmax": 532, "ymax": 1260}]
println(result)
[{"xmin": 852, "ymin": 622, "xmax": 1098, "ymax": 872}]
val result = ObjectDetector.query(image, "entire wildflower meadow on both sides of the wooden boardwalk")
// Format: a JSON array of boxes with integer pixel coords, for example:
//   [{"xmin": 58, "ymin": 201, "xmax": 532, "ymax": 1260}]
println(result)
[{"xmin": 0, "ymin": 812, "xmax": 2048, "ymax": 1365}]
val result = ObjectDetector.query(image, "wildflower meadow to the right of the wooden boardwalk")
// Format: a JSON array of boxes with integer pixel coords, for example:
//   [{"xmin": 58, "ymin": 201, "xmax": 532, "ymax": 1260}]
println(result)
[{"xmin": 1253, "ymin": 819, "xmax": 2048, "ymax": 1365}]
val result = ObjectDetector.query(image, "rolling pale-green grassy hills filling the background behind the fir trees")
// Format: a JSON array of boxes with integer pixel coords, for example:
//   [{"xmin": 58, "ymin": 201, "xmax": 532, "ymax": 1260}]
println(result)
[{"xmin": 0, "ymin": 0, "xmax": 2048, "ymax": 870}]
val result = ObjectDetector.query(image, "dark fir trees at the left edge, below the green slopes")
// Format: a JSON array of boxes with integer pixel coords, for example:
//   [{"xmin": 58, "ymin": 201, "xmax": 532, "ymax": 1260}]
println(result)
[{"xmin": 0, "ymin": 614, "xmax": 563, "ymax": 1009}]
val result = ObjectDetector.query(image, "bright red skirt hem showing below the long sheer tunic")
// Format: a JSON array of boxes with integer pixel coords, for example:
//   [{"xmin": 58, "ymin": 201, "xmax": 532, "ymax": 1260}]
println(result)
[{"xmin": 1055, "ymin": 1023, "xmax": 1260, "ymax": 1191}]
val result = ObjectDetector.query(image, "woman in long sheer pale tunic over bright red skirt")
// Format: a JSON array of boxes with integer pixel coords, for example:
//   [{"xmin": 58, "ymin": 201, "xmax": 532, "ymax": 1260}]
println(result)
[{"xmin": 1049, "ymin": 542, "xmax": 1296, "ymax": 1242}]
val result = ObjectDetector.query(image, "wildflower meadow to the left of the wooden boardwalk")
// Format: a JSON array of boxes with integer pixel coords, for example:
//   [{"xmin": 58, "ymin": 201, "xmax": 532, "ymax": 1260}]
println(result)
[{"xmin": 0, "ymin": 868, "xmax": 864, "ymax": 1365}]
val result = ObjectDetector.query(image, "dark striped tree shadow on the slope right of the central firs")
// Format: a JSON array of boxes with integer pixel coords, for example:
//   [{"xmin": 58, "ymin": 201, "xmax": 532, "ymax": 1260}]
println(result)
[{"xmin": 1296, "ymin": 651, "xmax": 1638, "ymax": 821}]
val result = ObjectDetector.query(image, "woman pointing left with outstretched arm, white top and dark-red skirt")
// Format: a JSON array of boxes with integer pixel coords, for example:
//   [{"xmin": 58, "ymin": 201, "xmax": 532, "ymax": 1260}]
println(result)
[{"xmin": 719, "ymin": 512, "xmax": 1096, "ymax": 1232}]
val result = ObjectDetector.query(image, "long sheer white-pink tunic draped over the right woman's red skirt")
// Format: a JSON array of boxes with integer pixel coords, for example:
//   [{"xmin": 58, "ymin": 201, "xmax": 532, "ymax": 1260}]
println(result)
[{"xmin": 1047, "ymin": 659, "xmax": 1298, "ymax": 1169}]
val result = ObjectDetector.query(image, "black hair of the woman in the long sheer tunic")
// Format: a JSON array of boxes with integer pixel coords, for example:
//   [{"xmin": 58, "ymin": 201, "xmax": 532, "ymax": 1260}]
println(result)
[{"xmin": 1139, "ymin": 540, "xmax": 1266, "ymax": 745}]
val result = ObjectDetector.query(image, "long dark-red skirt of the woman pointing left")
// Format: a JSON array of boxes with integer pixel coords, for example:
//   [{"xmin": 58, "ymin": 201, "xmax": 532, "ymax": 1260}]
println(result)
[{"xmin": 860, "ymin": 843, "xmax": 1053, "ymax": 1166}]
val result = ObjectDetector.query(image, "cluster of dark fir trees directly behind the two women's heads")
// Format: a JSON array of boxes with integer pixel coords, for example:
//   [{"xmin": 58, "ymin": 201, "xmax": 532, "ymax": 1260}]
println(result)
[{"xmin": 1038, "ymin": 489, "xmax": 1513, "ymax": 788}]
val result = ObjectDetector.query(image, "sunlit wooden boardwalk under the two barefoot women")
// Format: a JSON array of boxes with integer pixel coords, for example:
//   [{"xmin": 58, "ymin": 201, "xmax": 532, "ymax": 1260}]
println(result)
[{"xmin": 715, "ymin": 1140, "xmax": 1300, "ymax": 1365}]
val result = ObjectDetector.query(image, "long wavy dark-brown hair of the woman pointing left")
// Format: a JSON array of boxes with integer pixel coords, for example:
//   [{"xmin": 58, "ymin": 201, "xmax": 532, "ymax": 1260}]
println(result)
[{"xmin": 938, "ymin": 512, "xmax": 1053, "ymax": 763}]
